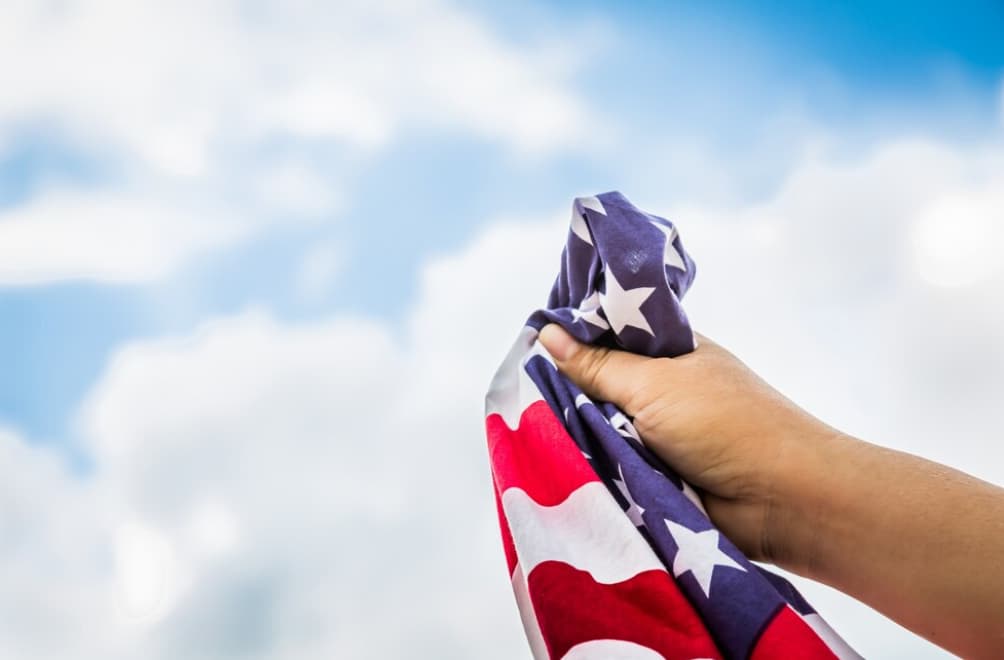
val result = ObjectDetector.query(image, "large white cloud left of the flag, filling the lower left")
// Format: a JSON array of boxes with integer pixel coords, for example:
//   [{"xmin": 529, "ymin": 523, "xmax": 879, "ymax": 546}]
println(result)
[{"xmin": 0, "ymin": 206, "xmax": 565, "ymax": 659}]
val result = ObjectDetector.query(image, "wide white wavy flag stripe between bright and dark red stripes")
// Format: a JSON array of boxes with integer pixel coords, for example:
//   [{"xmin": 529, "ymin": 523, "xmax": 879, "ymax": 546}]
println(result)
[{"xmin": 502, "ymin": 481, "xmax": 666, "ymax": 585}]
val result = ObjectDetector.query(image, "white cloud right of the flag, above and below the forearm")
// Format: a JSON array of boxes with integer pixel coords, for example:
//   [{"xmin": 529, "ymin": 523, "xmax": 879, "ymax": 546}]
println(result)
[{"xmin": 665, "ymin": 131, "xmax": 1004, "ymax": 657}]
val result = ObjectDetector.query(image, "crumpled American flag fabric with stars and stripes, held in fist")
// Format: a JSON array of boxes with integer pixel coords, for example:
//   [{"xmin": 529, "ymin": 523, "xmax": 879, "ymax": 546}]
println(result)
[{"xmin": 486, "ymin": 192, "xmax": 858, "ymax": 660}]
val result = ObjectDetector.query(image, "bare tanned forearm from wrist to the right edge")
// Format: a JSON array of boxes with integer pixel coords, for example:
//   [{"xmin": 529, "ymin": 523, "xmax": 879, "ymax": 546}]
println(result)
[{"xmin": 769, "ymin": 434, "xmax": 1004, "ymax": 657}]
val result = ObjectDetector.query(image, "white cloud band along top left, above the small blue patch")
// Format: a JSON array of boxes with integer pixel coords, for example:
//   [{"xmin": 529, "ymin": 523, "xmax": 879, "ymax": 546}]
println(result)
[{"xmin": 0, "ymin": 0, "xmax": 594, "ymax": 167}]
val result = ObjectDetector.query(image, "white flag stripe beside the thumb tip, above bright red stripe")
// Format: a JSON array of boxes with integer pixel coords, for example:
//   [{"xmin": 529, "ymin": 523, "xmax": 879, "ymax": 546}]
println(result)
[{"xmin": 485, "ymin": 325, "xmax": 554, "ymax": 430}]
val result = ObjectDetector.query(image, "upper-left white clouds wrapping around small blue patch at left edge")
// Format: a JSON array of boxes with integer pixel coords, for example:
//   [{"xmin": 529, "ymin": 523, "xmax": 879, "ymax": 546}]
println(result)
[{"xmin": 0, "ymin": 0, "xmax": 599, "ymax": 285}]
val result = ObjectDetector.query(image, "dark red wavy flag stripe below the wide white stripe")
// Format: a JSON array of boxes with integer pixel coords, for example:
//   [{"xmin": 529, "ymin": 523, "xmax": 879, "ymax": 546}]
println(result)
[{"xmin": 527, "ymin": 562, "xmax": 721, "ymax": 660}]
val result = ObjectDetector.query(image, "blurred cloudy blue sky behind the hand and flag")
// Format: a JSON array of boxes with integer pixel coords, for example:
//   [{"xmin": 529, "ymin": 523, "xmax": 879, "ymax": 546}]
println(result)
[{"xmin": 0, "ymin": 0, "xmax": 1004, "ymax": 660}]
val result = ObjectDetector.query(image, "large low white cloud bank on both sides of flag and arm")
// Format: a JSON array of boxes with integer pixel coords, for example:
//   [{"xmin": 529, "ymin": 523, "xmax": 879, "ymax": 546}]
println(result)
[{"xmin": 0, "ymin": 122, "xmax": 1004, "ymax": 658}]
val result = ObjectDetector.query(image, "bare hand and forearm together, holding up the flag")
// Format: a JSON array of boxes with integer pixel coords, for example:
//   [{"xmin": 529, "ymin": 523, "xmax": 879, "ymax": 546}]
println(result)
[{"xmin": 540, "ymin": 324, "xmax": 1004, "ymax": 658}]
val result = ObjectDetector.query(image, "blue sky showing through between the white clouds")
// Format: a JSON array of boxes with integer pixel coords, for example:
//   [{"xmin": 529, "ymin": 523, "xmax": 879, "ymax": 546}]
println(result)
[{"xmin": 0, "ymin": 2, "xmax": 1004, "ymax": 441}]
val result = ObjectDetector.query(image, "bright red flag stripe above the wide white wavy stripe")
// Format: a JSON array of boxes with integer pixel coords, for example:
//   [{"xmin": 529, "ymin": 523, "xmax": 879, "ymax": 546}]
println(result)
[{"xmin": 485, "ymin": 401, "xmax": 599, "ymax": 506}]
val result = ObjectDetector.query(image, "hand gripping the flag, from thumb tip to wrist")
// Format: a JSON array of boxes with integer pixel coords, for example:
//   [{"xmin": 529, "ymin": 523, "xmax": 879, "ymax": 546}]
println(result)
[{"xmin": 540, "ymin": 324, "xmax": 840, "ymax": 569}]
